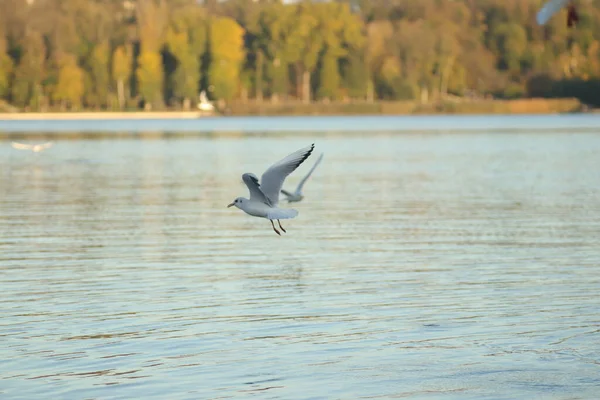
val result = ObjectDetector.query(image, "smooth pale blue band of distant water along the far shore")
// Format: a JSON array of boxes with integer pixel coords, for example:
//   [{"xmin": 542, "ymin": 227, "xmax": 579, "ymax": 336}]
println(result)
[{"xmin": 0, "ymin": 114, "xmax": 600, "ymax": 133}]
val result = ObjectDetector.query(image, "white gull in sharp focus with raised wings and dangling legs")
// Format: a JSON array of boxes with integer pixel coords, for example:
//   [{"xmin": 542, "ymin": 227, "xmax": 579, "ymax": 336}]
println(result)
[{"xmin": 227, "ymin": 143, "xmax": 315, "ymax": 236}]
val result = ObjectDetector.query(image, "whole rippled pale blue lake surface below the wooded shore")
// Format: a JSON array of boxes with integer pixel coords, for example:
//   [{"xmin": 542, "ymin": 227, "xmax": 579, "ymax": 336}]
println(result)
[{"xmin": 0, "ymin": 115, "xmax": 600, "ymax": 399}]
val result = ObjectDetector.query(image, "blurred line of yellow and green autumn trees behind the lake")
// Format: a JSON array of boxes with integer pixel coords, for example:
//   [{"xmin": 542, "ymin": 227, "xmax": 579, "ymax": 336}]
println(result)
[{"xmin": 0, "ymin": 0, "xmax": 600, "ymax": 110}]
